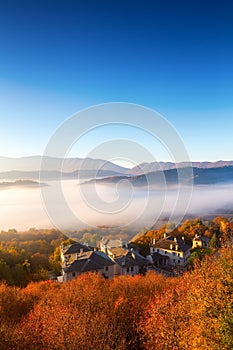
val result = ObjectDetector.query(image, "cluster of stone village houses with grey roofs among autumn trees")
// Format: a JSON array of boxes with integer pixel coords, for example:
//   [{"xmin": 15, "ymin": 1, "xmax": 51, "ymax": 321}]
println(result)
[{"xmin": 57, "ymin": 233, "xmax": 210, "ymax": 282}]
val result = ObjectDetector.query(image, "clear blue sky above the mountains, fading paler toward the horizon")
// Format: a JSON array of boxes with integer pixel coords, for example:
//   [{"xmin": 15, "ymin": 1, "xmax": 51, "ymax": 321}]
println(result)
[{"xmin": 0, "ymin": 0, "xmax": 233, "ymax": 160}]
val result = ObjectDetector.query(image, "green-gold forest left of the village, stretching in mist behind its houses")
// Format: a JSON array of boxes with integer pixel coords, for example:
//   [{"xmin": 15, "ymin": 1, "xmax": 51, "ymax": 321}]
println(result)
[{"xmin": 0, "ymin": 226, "xmax": 139, "ymax": 287}]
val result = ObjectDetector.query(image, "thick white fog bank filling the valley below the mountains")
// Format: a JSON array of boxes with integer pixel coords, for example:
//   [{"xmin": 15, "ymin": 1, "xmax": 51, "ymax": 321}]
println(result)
[{"xmin": 0, "ymin": 180, "xmax": 233, "ymax": 230}]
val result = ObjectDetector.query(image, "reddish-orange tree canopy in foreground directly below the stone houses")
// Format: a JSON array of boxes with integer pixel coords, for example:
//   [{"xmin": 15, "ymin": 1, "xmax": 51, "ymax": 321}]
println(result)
[{"xmin": 12, "ymin": 274, "xmax": 165, "ymax": 350}]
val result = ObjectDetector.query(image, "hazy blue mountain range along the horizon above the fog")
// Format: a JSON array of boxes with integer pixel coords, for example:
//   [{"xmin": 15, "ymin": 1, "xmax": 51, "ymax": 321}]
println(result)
[{"xmin": 0, "ymin": 156, "xmax": 233, "ymax": 186}]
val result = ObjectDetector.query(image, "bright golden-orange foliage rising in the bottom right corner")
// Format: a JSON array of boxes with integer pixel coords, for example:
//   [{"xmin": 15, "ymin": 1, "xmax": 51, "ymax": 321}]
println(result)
[{"xmin": 140, "ymin": 249, "xmax": 233, "ymax": 350}]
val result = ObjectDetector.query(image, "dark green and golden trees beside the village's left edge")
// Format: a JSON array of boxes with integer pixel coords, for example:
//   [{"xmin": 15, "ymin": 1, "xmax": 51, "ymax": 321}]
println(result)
[{"xmin": 0, "ymin": 228, "xmax": 67, "ymax": 287}]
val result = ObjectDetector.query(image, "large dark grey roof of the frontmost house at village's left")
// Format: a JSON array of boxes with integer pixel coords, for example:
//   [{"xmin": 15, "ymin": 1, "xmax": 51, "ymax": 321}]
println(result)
[{"xmin": 64, "ymin": 251, "xmax": 115, "ymax": 273}]
